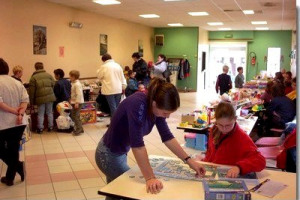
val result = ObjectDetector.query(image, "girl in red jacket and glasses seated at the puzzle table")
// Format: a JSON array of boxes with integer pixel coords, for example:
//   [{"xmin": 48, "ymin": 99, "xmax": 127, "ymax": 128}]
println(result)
[{"xmin": 203, "ymin": 102, "xmax": 266, "ymax": 178}]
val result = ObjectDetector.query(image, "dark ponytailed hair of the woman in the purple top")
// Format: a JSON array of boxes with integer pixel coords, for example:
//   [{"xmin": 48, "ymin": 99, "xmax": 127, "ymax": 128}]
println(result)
[{"xmin": 147, "ymin": 78, "xmax": 180, "ymax": 117}]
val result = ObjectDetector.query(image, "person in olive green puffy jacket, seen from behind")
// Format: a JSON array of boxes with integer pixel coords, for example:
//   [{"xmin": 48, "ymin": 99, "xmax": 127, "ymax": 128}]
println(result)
[{"xmin": 29, "ymin": 62, "xmax": 56, "ymax": 133}]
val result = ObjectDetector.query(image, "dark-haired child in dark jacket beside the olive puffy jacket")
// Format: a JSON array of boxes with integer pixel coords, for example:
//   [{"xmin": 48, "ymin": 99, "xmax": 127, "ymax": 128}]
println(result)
[{"xmin": 53, "ymin": 69, "xmax": 71, "ymax": 108}]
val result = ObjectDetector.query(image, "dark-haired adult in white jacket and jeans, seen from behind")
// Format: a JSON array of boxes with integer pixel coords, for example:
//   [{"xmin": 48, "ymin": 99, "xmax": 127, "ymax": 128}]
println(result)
[{"xmin": 97, "ymin": 54, "xmax": 127, "ymax": 125}]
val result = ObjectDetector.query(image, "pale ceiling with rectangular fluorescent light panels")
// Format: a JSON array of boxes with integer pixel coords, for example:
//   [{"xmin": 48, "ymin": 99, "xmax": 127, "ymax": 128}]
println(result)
[{"xmin": 47, "ymin": 0, "xmax": 296, "ymax": 31}]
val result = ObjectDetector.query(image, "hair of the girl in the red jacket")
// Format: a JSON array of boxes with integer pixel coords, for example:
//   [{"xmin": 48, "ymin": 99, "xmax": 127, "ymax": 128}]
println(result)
[{"xmin": 212, "ymin": 101, "xmax": 236, "ymax": 145}]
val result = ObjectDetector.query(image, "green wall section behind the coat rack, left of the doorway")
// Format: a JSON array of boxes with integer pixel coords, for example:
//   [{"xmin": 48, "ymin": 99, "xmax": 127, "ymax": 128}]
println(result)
[{"xmin": 154, "ymin": 27, "xmax": 199, "ymax": 91}]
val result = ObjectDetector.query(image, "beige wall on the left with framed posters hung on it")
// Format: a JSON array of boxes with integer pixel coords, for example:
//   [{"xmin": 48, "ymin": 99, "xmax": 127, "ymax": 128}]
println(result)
[{"xmin": 0, "ymin": 0, "xmax": 153, "ymax": 82}]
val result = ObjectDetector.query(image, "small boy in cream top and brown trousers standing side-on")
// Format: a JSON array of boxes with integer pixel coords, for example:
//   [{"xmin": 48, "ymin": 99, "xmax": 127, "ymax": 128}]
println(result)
[{"xmin": 69, "ymin": 70, "xmax": 84, "ymax": 136}]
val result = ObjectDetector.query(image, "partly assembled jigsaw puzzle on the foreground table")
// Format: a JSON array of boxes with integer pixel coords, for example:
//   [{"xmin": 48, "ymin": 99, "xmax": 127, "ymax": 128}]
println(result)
[{"xmin": 150, "ymin": 158, "xmax": 216, "ymax": 181}]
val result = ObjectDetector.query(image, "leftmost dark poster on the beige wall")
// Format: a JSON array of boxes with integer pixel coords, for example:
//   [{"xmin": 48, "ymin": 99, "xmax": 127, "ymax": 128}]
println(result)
[{"xmin": 33, "ymin": 25, "xmax": 47, "ymax": 55}]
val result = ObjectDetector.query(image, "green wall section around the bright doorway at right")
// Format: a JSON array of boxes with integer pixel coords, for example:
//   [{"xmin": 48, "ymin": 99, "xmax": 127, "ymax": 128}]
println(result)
[{"xmin": 209, "ymin": 31, "xmax": 292, "ymax": 80}]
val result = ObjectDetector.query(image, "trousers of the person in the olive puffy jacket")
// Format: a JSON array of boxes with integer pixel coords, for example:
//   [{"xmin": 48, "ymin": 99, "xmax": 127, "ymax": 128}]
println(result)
[{"xmin": 37, "ymin": 102, "xmax": 53, "ymax": 129}]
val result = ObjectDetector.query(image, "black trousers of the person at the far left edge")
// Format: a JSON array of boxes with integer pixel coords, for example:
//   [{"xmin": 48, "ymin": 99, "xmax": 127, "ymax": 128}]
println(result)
[{"xmin": 0, "ymin": 125, "xmax": 26, "ymax": 181}]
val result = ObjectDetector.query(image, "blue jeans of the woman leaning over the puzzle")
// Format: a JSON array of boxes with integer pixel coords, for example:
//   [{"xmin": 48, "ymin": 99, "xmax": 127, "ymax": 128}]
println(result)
[{"xmin": 95, "ymin": 139, "xmax": 130, "ymax": 200}]
